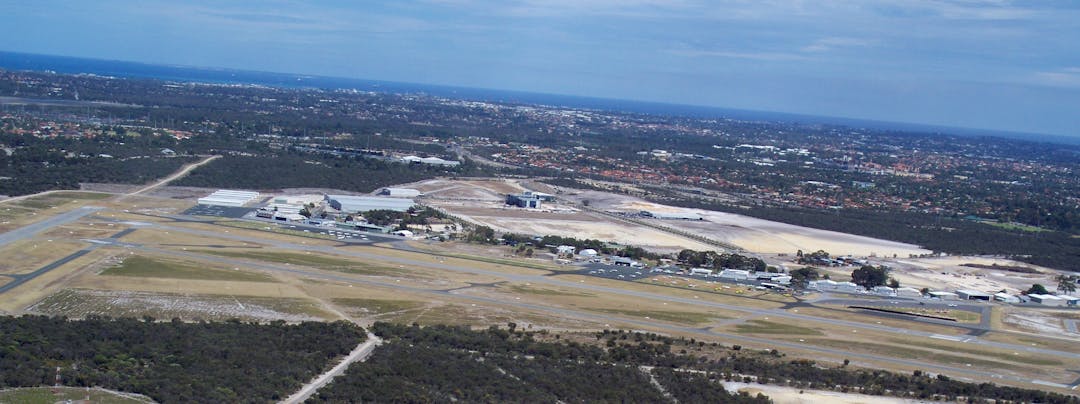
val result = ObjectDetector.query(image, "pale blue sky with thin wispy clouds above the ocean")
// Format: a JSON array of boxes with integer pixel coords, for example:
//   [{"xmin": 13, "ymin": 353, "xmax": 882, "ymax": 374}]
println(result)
[{"xmin": 0, "ymin": 0, "xmax": 1080, "ymax": 137}]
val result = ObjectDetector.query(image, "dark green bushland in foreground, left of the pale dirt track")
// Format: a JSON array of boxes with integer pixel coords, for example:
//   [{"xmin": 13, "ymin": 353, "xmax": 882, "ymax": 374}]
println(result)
[{"xmin": 0, "ymin": 315, "xmax": 366, "ymax": 403}]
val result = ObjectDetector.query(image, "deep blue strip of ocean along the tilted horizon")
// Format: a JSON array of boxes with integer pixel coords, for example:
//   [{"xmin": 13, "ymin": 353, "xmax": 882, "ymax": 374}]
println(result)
[{"xmin": 0, "ymin": 51, "xmax": 1080, "ymax": 145}]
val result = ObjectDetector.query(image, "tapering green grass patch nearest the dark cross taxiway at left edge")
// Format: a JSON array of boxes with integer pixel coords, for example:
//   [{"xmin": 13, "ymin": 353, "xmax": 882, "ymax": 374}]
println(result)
[{"xmin": 102, "ymin": 255, "xmax": 275, "ymax": 282}]
